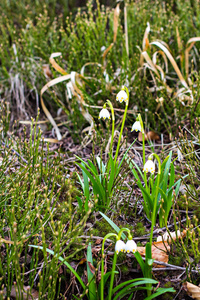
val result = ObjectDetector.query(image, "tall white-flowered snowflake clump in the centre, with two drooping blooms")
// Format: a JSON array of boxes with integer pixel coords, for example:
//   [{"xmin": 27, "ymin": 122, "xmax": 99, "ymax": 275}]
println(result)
[{"xmin": 76, "ymin": 87, "xmax": 135, "ymax": 211}]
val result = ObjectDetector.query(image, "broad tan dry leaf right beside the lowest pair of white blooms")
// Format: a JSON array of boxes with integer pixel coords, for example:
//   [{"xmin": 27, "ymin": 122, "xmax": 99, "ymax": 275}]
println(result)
[{"xmin": 137, "ymin": 242, "xmax": 170, "ymax": 268}]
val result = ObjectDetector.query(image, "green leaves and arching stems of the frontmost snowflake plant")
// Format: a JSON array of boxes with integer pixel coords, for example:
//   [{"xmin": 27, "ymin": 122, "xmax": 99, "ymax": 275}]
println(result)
[{"xmin": 29, "ymin": 228, "xmax": 174, "ymax": 300}]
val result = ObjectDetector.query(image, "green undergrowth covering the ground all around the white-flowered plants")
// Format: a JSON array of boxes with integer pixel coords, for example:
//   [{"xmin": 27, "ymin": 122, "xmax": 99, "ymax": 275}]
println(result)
[{"xmin": 0, "ymin": 0, "xmax": 200, "ymax": 299}]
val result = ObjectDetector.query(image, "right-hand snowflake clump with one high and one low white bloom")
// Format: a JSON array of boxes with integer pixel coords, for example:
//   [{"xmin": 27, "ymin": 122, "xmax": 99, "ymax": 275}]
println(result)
[{"xmin": 126, "ymin": 114, "xmax": 182, "ymax": 227}]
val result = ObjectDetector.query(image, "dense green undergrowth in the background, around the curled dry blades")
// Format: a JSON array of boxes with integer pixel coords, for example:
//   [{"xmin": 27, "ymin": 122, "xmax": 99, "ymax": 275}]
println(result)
[{"xmin": 0, "ymin": 0, "xmax": 200, "ymax": 136}]
